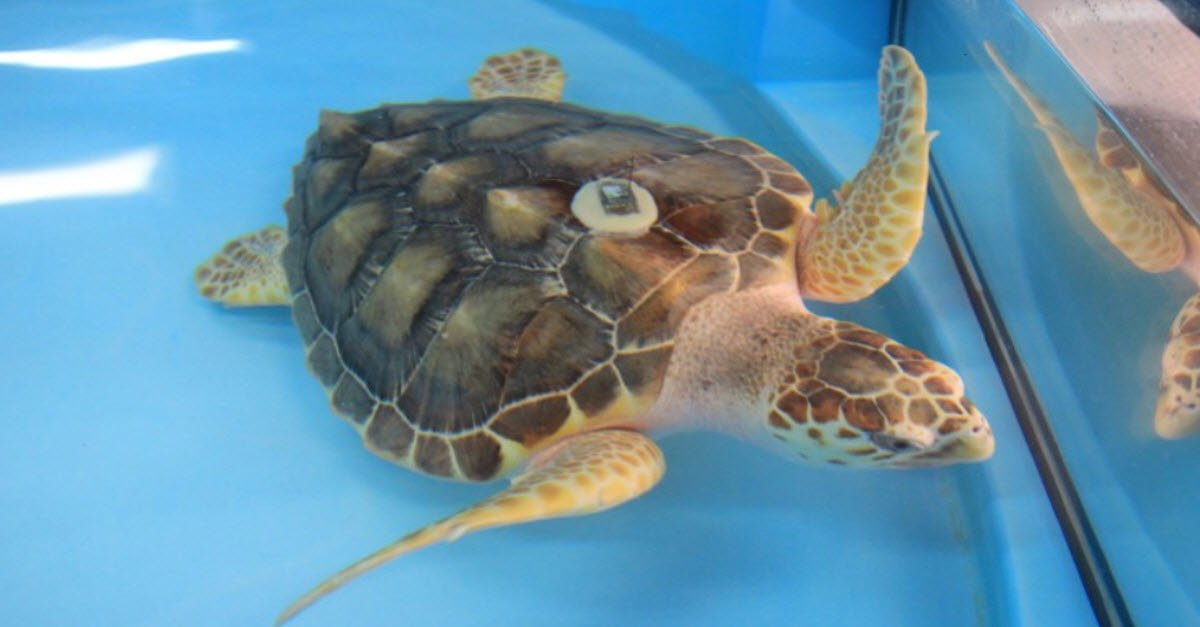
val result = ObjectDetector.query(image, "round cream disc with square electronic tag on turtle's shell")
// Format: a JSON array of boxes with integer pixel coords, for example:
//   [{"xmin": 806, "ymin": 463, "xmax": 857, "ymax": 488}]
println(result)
[{"xmin": 571, "ymin": 179, "xmax": 659, "ymax": 237}]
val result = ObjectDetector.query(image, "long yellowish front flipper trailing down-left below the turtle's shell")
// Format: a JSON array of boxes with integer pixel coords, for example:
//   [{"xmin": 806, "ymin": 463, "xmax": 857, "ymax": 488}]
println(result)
[{"xmin": 275, "ymin": 430, "xmax": 666, "ymax": 625}]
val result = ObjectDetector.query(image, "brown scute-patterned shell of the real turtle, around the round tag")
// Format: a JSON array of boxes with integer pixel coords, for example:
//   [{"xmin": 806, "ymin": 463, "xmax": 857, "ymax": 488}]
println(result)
[{"xmin": 284, "ymin": 98, "xmax": 811, "ymax": 480}]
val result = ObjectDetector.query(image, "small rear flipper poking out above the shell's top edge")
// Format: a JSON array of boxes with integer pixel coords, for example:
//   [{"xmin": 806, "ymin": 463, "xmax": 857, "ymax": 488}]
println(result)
[{"xmin": 467, "ymin": 48, "xmax": 566, "ymax": 102}]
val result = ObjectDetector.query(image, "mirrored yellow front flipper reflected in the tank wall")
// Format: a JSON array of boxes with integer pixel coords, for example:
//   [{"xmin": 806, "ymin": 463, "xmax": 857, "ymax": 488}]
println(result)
[{"xmin": 984, "ymin": 42, "xmax": 1187, "ymax": 273}]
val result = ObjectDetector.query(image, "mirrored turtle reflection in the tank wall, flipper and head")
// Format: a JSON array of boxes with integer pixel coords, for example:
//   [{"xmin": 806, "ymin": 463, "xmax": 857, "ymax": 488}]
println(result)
[{"xmin": 984, "ymin": 42, "xmax": 1200, "ymax": 440}]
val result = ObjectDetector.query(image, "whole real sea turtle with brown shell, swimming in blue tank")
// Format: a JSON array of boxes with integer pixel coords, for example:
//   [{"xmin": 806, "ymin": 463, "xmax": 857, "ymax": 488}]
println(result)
[{"xmin": 196, "ymin": 47, "xmax": 994, "ymax": 620}]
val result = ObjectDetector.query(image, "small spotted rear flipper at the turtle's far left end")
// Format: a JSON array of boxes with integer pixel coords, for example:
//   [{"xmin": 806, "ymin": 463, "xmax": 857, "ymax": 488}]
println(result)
[{"xmin": 196, "ymin": 225, "xmax": 292, "ymax": 306}]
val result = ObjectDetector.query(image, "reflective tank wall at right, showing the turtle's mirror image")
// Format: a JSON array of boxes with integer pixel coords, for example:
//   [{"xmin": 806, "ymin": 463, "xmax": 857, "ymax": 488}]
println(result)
[{"xmin": 905, "ymin": 1, "xmax": 1200, "ymax": 625}]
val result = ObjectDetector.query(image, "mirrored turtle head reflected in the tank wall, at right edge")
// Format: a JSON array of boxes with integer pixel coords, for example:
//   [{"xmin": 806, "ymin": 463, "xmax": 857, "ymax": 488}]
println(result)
[{"xmin": 1154, "ymin": 294, "xmax": 1200, "ymax": 440}]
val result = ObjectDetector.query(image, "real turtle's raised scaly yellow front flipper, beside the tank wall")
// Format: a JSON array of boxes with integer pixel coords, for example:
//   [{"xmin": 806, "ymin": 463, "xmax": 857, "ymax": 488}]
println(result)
[{"xmin": 800, "ymin": 46, "xmax": 937, "ymax": 303}]
